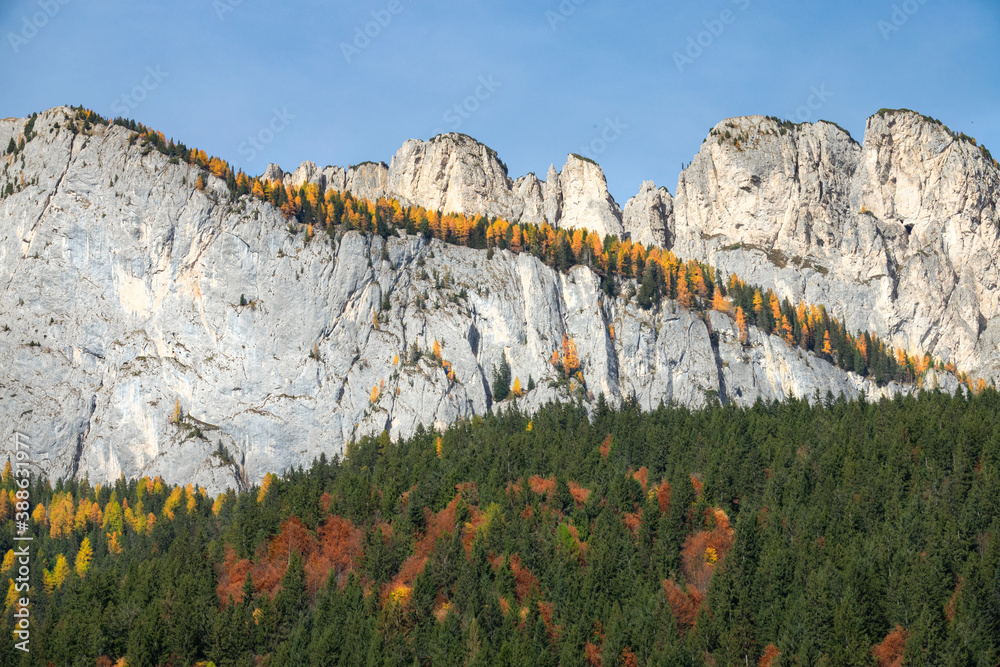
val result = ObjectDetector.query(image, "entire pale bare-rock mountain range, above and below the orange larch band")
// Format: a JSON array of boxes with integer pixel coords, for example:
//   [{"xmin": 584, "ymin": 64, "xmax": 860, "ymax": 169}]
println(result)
[{"xmin": 0, "ymin": 107, "xmax": 1000, "ymax": 491}]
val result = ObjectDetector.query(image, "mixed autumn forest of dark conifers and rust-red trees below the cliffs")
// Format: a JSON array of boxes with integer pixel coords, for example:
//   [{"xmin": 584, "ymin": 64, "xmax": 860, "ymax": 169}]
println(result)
[{"xmin": 0, "ymin": 388, "xmax": 1000, "ymax": 667}]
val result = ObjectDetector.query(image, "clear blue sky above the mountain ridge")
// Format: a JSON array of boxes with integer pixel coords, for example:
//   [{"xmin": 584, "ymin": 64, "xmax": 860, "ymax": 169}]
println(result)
[{"xmin": 0, "ymin": 0, "xmax": 1000, "ymax": 204}]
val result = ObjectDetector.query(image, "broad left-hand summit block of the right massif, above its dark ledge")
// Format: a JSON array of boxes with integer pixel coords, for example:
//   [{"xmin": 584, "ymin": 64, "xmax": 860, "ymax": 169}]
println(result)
[{"xmin": 675, "ymin": 116, "xmax": 860, "ymax": 256}]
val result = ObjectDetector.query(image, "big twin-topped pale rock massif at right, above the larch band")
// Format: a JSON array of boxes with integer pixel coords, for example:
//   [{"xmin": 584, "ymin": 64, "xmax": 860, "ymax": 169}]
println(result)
[{"xmin": 672, "ymin": 111, "xmax": 1000, "ymax": 379}]
